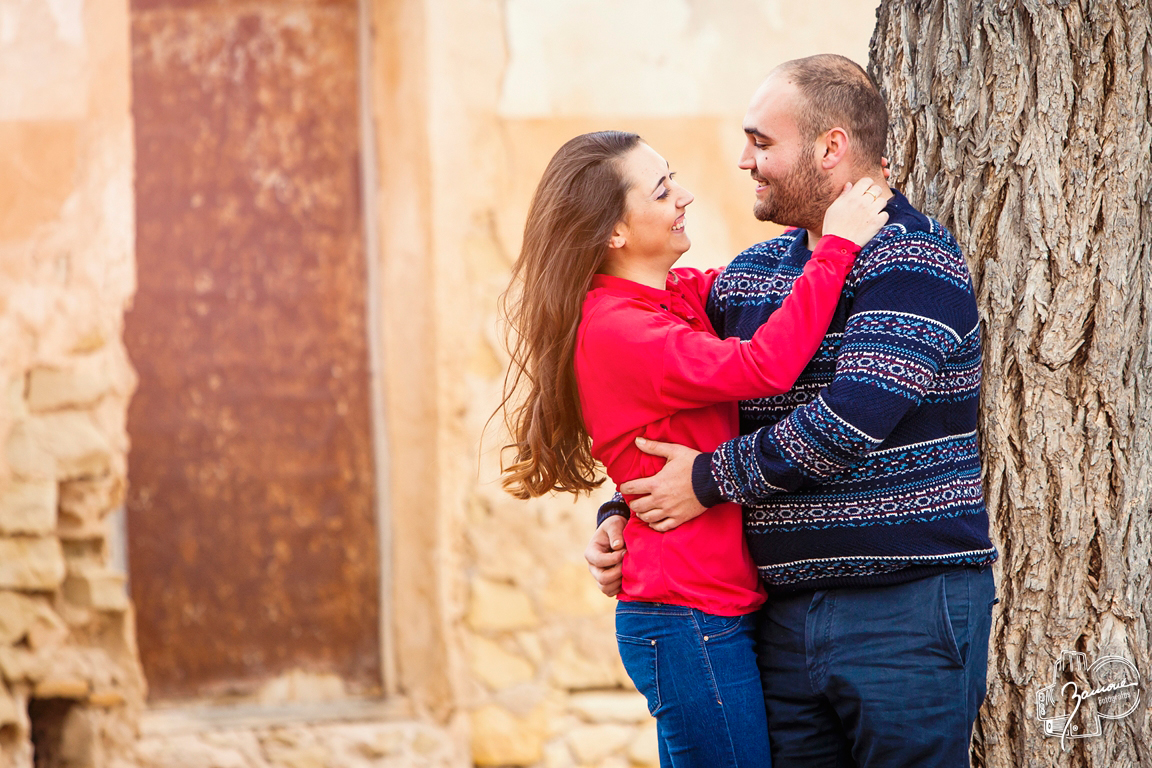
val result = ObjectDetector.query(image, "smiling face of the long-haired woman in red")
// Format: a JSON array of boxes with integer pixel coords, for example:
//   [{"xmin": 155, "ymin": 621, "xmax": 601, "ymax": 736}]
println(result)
[{"xmin": 616, "ymin": 142, "xmax": 692, "ymax": 261}]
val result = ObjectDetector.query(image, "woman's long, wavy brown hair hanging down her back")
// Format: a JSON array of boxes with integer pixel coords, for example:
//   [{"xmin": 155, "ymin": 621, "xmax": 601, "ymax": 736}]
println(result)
[{"xmin": 498, "ymin": 131, "xmax": 641, "ymax": 499}]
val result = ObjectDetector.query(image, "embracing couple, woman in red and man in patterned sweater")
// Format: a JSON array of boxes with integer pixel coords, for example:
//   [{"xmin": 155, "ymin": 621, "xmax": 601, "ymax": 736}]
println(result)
[{"xmin": 503, "ymin": 55, "xmax": 996, "ymax": 768}]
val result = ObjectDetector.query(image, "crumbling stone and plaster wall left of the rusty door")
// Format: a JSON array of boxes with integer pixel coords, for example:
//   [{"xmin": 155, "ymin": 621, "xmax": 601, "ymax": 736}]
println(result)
[{"xmin": 0, "ymin": 0, "xmax": 144, "ymax": 768}]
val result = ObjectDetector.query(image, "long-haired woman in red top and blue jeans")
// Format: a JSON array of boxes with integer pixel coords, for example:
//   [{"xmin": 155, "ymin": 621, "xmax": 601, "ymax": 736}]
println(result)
[{"xmin": 502, "ymin": 131, "xmax": 887, "ymax": 768}]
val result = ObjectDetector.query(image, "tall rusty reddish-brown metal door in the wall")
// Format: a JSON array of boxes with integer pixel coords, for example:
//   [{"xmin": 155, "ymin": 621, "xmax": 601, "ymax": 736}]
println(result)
[{"xmin": 126, "ymin": 0, "xmax": 380, "ymax": 699}]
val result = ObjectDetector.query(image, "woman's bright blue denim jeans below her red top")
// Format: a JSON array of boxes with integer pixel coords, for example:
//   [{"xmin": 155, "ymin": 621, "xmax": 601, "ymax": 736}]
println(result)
[{"xmin": 616, "ymin": 601, "xmax": 772, "ymax": 768}]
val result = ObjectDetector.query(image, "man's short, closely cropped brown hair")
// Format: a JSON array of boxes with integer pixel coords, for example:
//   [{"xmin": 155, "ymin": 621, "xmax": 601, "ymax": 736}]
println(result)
[{"xmin": 776, "ymin": 53, "xmax": 888, "ymax": 167}]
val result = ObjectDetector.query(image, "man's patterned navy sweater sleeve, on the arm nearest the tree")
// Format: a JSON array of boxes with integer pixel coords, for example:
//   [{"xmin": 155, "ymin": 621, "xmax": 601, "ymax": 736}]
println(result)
[{"xmin": 692, "ymin": 226, "xmax": 978, "ymax": 505}]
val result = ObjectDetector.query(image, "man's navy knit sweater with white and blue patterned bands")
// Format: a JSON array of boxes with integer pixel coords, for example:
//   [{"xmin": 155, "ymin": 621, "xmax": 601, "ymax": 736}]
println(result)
[{"xmin": 692, "ymin": 192, "xmax": 996, "ymax": 591}]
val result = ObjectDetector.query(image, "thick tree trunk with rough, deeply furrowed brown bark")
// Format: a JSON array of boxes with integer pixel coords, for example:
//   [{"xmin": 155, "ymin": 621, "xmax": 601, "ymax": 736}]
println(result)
[{"xmin": 870, "ymin": 0, "xmax": 1152, "ymax": 768}]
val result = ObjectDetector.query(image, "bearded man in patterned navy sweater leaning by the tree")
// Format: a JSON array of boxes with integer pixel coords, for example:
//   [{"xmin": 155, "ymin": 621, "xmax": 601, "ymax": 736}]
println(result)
[{"xmin": 585, "ymin": 55, "xmax": 996, "ymax": 768}]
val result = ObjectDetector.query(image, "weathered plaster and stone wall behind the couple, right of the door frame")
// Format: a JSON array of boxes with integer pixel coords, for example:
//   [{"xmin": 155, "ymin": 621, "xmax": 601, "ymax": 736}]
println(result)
[{"xmin": 417, "ymin": 0, "xmax": 874, "ymax": 768}]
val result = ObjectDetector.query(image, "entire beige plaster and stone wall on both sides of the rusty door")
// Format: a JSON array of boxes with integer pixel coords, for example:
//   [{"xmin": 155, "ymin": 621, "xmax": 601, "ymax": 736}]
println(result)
[{"xmin": 0, "ymin": 0, "xmax": 874, "ymax": 768}]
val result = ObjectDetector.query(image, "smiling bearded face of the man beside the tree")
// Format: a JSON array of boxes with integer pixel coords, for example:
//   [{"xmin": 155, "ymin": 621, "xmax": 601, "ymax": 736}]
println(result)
[{"xmin": 740, "ymin": 76, "xmax": 835, "ymax": 230}]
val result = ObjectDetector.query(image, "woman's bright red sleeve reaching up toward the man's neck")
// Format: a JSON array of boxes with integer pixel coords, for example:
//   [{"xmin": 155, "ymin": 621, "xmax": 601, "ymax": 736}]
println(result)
[{"xmin": 659, "ymin": 235, "xmax": 859, "ymax": 410}]
